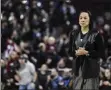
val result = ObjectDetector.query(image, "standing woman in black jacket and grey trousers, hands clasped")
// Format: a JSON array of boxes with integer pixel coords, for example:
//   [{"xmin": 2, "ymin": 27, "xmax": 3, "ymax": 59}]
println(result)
[{"xmin": 69, "ymin": 11, "xmax": 105, "ymax": 90}]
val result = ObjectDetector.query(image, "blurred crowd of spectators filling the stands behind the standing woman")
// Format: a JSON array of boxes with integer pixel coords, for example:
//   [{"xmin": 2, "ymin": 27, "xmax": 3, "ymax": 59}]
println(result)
[{"xmin": 0, "ymin": 0, "xmax": 111, "ymax": 90}]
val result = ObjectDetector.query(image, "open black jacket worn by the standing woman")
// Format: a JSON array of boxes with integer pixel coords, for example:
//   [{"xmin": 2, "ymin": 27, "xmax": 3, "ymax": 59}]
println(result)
[{"xmin": 68, "ymin": 30, "xmax": 105, "ymax": 78}]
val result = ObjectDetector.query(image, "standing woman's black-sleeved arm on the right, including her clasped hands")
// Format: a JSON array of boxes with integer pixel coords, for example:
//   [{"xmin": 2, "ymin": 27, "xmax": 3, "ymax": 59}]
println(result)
[{"xmin": 76, "ymin": 33, "xmax": 106, "ymax": 61}]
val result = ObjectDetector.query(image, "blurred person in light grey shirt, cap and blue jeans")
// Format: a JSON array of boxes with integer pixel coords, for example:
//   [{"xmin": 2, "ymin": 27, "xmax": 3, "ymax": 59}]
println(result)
[{"xmin": 15, "ymin": 54, "xmax": 37, "ymax": 90}]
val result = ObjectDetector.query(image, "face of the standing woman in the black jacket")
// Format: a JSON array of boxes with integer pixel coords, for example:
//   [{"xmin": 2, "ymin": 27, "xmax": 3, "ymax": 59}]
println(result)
[{"xmin": 79, "ymin": 12, "xmax": 90, "ymax": 27}]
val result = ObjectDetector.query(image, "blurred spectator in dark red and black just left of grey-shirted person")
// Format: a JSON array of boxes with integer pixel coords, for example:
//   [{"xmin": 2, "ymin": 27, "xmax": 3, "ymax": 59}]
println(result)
[{"xmin": 3, "ymin": 51, "xmax": 19, "ymax": 90}]
